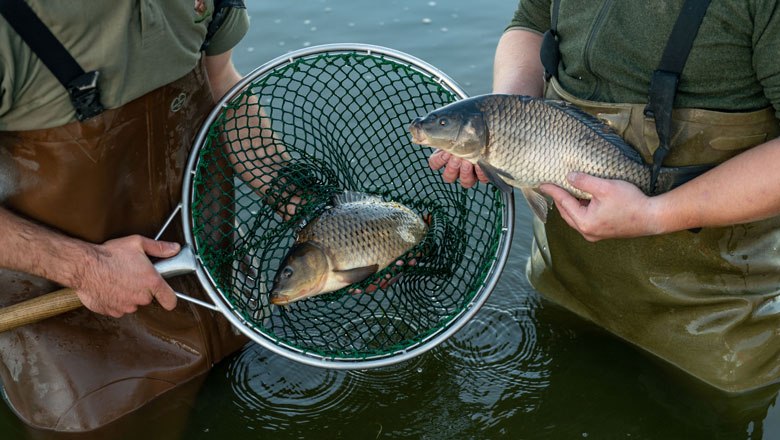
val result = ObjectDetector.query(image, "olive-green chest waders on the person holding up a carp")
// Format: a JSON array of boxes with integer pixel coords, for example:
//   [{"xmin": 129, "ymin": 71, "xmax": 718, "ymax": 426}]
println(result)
[{"xmin": 540, "ymin": 0, "xmax": 780, "ymax": 392}]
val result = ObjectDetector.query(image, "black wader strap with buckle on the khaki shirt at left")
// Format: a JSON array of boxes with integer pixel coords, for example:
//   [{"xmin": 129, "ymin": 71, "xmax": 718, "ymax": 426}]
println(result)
[{"xmin": 0, "ymin": 0, "xmax": 103, "ymax": 121}]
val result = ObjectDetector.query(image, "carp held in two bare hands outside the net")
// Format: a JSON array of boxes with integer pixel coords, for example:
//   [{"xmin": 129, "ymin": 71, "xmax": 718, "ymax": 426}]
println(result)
[{"xmin": 409, "ymin": 94, "xmax": 701, "ymax": 221}]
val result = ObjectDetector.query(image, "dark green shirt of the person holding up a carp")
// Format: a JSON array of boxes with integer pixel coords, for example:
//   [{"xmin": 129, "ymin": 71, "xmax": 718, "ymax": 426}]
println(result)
[{"xmin": 509, "ymin": 0, "xmax": 780, "ymax": 117}]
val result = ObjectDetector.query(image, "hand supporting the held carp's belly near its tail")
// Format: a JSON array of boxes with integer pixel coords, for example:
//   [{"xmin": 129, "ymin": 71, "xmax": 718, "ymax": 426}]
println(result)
[{"xmin": 539, "ymin": 173, "xmax": 662, "ymax": 242}]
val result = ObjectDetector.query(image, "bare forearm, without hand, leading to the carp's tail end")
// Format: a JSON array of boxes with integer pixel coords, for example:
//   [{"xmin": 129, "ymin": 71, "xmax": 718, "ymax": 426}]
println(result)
[{"xmin": 650, "ymin": 139, "xmax": 780, "ymax": 232}]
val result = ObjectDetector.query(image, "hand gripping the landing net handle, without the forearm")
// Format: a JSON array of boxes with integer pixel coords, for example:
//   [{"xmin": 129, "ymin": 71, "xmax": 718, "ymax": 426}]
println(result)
[{"xmin": 74, "ymin": 235, "xmax": 180, "ymax": 318}]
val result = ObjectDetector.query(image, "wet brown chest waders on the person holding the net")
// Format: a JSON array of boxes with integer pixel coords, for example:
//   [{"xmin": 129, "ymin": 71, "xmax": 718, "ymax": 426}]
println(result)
[{"xmin": 0, "ymin": 0, "xmax": 247, "ymax": 432}]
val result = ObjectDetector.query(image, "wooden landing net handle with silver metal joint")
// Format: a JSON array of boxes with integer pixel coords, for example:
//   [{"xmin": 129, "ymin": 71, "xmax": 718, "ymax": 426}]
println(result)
[{"xmin": 0, "ymin": 246, "xmax": 220, "ymax": 333}]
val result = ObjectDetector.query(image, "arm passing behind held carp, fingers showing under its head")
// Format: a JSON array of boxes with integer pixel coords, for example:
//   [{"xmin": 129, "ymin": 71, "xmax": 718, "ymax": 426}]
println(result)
[{"xmin": 428, "ymin": 28, "xmax": 544, "ymax": 188}]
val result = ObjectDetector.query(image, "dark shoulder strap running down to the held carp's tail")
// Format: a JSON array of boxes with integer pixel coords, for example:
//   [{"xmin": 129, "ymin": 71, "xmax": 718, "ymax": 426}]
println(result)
[{"xmin": 644, "ymin": 0, "xmax": 710, "ymax": 188}]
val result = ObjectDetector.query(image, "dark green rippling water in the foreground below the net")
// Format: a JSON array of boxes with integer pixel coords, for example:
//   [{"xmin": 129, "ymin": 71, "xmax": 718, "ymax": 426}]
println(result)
[{"xmin": 180, "ymin": 200, "xmax": 779, "ymax": 440}]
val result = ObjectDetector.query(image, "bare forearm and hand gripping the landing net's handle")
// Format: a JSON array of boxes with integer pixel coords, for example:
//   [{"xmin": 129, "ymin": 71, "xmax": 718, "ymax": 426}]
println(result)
[{"xmin": 0, "ymin": 207, "xmax": 179, "ymax": 317}]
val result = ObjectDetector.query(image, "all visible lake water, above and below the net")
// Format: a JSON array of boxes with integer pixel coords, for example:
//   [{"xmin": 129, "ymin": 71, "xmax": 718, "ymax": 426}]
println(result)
[{"xmin": 0, "ymin": 0, "xmax": 780, "ymax": 440}]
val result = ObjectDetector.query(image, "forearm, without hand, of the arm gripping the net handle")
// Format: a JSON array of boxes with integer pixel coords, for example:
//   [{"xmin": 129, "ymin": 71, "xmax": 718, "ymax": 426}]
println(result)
[{"xmin": 0, "ymin": 207, "xmax": 99, "ymax": 287}]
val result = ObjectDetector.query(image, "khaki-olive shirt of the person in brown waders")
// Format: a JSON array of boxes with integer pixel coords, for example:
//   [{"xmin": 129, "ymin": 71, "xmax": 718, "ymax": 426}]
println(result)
[{"xmin": 0, "ymin": 0, "xmax": 249, "ymax": 131}]
